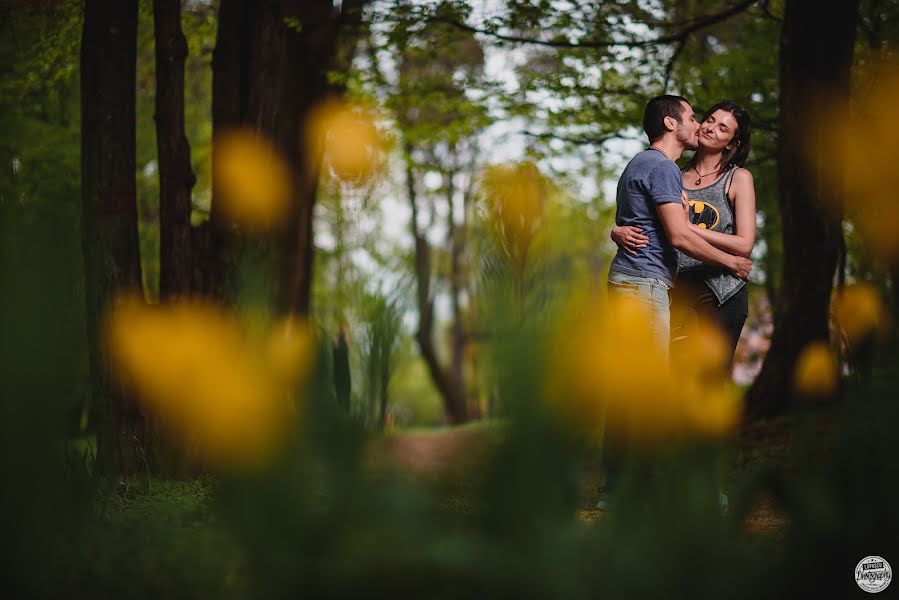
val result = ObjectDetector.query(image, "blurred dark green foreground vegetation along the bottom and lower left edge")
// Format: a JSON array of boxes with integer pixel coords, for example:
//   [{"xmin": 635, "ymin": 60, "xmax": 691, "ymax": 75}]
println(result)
[{"xmin": 0, "ymin": 198, "xmax": 899, "ymax": 598}]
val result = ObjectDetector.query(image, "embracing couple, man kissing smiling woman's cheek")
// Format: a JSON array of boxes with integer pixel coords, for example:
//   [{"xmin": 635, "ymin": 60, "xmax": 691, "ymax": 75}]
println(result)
[{"xmin": 600, "ymin": 95, "xmax": 756, "ymax": 508}]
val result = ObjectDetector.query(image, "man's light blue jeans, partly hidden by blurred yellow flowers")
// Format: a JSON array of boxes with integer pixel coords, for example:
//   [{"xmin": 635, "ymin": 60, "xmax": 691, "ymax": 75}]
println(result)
[{"xmin": 602, "ymin": 271, "xmax": 671, "ymax": 492}]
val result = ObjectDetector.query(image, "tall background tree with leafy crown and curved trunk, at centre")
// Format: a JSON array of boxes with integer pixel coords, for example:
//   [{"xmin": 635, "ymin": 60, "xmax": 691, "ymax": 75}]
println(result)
[{"xmin": 390, "ymin": 8, "xmax": 489, "ymax": 423}]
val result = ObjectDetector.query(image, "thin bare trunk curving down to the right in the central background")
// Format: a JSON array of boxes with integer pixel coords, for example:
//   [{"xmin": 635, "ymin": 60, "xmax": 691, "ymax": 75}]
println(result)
[{"xmin": 406, "ymin": 152, "xmax": 468, "ymax": 423}]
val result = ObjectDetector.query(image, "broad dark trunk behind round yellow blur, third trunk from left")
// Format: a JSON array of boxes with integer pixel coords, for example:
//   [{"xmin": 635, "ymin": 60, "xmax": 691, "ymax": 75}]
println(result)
[{"xmin": 198, "ymin": 0, "xmax": 369, "ymax": 314}]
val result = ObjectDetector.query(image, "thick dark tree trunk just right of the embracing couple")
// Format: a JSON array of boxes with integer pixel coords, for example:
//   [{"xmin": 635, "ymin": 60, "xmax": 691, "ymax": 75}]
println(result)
[{"xmin": 747, "ymin": 0, "xmax": 858, "ymax": 417}]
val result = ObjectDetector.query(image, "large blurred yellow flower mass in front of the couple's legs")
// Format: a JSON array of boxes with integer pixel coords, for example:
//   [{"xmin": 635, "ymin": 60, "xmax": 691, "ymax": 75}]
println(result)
[{"xmin": 548, "ymin": 297, "xmax": 740, "ymax": 445}]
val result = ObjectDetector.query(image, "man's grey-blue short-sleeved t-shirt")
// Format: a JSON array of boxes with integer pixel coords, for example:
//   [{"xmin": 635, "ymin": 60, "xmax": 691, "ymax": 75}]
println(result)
[{"xmin": 611, "ymin": 148, "xmax": 681, "ymax": 285}]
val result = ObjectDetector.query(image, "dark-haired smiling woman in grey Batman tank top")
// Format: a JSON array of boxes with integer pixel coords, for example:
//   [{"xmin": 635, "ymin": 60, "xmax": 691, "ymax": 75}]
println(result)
[{"xmin": 611, "ymin": 100, "xmax": 755, "ymax": 367}]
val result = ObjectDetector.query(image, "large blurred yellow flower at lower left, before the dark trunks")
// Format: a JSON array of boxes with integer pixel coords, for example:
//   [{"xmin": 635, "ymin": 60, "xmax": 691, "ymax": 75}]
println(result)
[{"xmin": 104, "ymin": 298, "xmax": 312, "ymax": 466}]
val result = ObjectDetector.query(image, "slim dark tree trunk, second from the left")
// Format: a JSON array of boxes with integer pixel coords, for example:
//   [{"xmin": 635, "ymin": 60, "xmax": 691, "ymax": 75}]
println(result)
[{"xmin": 153, "ymin": 0, "xmax": 196, "ymax": 299}]
